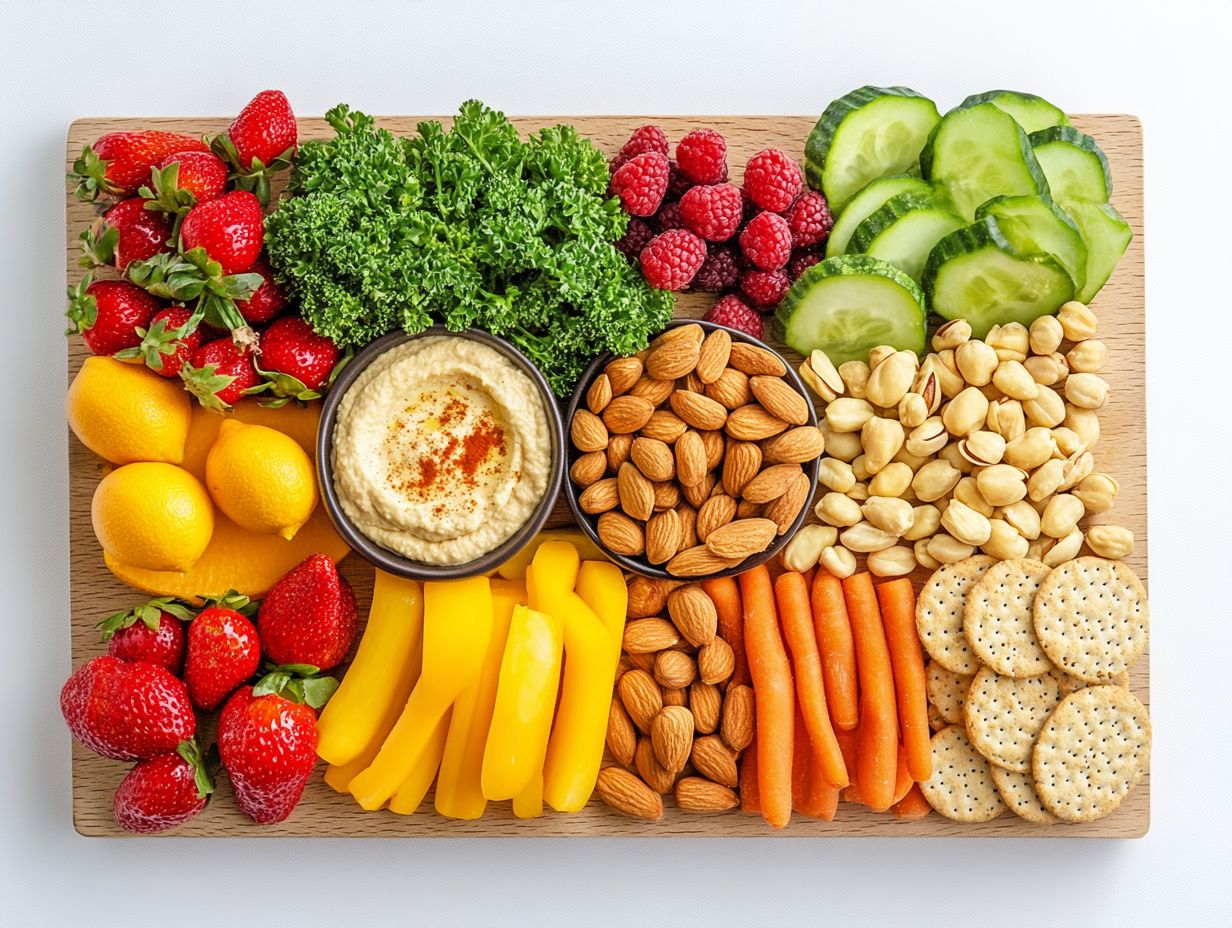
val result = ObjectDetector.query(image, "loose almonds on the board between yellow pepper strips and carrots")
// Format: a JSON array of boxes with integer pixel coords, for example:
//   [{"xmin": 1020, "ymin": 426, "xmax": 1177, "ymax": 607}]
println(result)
[{"xmin": 596, "ymin": 577, "xmax": 754, "ymax": 821}]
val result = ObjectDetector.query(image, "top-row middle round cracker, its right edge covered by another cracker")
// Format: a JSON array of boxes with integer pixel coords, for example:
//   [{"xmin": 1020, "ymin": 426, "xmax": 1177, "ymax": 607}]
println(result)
[{"xmin": 962, "ymin": 557, "xmax": 1052, "ymax": 678}]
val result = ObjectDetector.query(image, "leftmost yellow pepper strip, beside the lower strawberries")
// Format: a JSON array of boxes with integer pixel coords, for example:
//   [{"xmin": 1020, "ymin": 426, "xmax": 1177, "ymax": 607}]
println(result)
[{"xmin": 317, "ymin": 571, "xmax": 424, "ymax": 767}]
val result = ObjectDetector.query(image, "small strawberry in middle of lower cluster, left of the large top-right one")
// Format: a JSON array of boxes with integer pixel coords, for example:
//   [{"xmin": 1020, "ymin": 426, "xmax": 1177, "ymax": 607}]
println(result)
[{"xmin": 184, "ymin": 606, "xmax": 261, "ymax": 709}]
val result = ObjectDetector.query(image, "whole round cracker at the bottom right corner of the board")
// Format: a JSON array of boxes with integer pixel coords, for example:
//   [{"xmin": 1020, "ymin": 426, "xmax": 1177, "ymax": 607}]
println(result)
[{"xmin": 1031, "ymin": 686, "xmax": 1151, "ymax": 822}]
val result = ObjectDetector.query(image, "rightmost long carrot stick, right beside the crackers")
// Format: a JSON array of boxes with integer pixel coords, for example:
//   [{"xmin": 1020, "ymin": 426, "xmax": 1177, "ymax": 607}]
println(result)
[{"xmin": 877, "ymin": 577, "xmax": 933, "ymax": 783}]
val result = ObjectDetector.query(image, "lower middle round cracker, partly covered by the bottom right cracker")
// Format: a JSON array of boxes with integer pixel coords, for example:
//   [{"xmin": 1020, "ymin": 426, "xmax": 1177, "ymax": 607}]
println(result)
[{"xmin": 962, "ymin": 667, "xmax": 1061, "ymax": 773}]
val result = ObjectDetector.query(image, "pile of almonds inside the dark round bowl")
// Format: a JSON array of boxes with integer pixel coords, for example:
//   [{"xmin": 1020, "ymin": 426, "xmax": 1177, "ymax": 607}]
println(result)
[{"xmin": 569, "ymin": 323, "xmax": 823, "ymax": 577}]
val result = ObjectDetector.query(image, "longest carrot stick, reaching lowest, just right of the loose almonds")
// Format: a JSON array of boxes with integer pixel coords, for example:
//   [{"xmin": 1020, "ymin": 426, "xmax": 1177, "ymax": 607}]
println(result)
[{"xmin": 739, "ymin": 564, "xmax": 796, "ymax": 828}]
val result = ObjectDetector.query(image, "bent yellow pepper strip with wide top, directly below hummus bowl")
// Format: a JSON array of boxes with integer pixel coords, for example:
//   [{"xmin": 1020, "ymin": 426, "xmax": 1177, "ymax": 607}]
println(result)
[{"xmin": 350, "ymin": 577, "xmax": 492, "ymax": 810}]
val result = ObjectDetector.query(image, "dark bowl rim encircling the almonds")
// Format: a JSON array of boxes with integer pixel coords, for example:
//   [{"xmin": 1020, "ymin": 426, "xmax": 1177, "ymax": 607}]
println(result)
[{"xmin": 564, "ymin": 319, "xmax": 821, "ymax": 580}]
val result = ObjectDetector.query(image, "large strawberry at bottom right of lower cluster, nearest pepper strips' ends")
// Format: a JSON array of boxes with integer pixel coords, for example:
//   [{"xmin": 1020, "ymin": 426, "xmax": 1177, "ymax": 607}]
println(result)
[{"xmin": 218, "ymin": 686, "xmax": 317, "ymax": 824}]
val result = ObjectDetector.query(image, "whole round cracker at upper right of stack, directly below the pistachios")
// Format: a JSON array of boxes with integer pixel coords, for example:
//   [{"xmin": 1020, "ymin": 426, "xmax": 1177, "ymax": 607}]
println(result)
[{"xmin": 1032, "ymin": 557, "xmax": 1149, "ymax": 683}]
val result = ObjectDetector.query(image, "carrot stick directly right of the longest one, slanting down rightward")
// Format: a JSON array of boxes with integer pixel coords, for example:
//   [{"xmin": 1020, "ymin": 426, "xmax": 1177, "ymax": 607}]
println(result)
[{"xmin": 774, "ymin": 571, "xmax": 851, "ymax": 789}]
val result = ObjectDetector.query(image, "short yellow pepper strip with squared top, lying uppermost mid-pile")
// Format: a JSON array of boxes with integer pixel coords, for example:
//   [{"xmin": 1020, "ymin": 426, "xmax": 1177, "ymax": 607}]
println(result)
[{"xmin": 479, "ymin": 596, "xmax": 564, "ymax": 801}]
